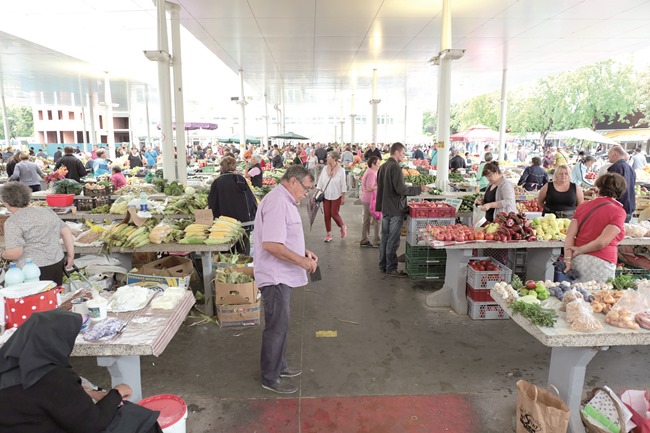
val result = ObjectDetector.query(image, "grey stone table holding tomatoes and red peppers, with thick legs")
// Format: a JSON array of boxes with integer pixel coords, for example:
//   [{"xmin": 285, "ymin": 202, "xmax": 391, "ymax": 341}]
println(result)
[{"xmin": 426, "ymin": 238, "xmax": 650, "ymax": 314}]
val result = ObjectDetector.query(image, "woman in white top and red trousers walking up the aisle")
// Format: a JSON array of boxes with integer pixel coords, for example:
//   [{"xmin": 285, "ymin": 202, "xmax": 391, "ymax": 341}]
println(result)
[{"xmin": 316, "ymin": 151, "xmax": 348, "ymax": 242}]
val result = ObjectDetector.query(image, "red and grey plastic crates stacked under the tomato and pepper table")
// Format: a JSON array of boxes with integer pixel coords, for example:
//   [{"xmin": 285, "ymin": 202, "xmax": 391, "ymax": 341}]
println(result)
[{"xmin": 466, "ymin": 257, "xmax": 512, "ymax": 320}]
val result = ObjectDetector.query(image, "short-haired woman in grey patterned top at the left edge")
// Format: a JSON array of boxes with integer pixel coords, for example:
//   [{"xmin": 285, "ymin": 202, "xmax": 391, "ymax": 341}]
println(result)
[{"xmin": 0, "ymin": 182, "xmax": 74, "ymax": 284}]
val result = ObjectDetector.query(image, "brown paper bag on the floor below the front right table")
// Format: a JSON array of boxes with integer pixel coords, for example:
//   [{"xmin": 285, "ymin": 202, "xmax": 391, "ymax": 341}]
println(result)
[{"xmin": 516, "ymin": 380, "xmax": 570, "ymax": 433}]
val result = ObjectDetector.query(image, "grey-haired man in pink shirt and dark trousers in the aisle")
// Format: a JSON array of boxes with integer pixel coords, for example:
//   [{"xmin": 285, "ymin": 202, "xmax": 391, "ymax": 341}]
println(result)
[{"xmin": 253, "ymin": 165, "xmax": 318, "ymax": 394}]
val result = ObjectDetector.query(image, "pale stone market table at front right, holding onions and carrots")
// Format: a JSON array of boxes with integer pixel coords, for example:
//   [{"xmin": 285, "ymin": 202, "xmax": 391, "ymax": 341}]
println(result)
[{"xmin": 491, "ymin": 290, "xmax": 650, "ymax": 433}]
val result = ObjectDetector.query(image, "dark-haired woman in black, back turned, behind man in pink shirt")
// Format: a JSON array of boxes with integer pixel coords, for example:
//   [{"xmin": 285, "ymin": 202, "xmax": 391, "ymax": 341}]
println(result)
[{"xmin": 208, "ymin": 156, "xmax": 257, "ymax": 254}]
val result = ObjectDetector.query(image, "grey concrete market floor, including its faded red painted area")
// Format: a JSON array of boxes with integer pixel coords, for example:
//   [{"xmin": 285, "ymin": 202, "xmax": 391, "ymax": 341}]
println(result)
[{"xmin": 72, "ymin": 199, "xmax": 650, "ymax": 433}]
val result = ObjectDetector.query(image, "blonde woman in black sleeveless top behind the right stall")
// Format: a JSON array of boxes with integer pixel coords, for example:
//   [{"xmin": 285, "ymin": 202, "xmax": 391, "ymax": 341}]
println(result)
[{"xmin": 537, "ymin": 164, "xmax": 584, "ymax": 218}]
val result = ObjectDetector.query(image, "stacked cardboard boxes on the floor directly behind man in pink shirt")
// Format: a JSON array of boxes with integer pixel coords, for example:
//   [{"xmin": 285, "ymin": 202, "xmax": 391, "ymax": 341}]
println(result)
[{"xmin": 214, "ymin": 266, "xmax": 260, "ymax": 328}]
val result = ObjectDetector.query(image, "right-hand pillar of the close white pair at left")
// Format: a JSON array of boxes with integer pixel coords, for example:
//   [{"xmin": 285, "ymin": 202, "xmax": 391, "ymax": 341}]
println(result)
[{"xmin": 169, "ymin": 3, "xmax": 187, "ymax": 183}]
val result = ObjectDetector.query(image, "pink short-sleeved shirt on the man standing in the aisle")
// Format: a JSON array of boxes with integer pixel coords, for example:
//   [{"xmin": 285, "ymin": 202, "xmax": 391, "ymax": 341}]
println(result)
[{"xmin": 253, "ymin": 184, "xmax": 307, "ymax": 287}]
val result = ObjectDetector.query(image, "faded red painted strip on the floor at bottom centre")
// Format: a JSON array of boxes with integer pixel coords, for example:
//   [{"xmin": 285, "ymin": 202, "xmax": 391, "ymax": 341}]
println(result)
[{"xmin": 223, "ymin": 394, "xmax": 479, "ymax": 433}]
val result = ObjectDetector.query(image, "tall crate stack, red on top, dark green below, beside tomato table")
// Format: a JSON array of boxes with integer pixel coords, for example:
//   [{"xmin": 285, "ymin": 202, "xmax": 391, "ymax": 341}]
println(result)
[{"xmin": 405, "ymin": 202, "xmax": 456, "ymax": 280}]
